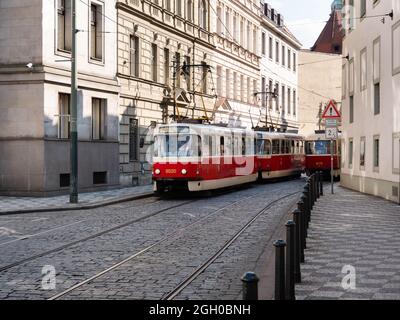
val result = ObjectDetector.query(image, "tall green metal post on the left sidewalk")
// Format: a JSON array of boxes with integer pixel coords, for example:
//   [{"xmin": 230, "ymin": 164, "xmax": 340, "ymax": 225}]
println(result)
[{"xmin": 70, "ymin": 0, "xmax": 79, "ymax": 203}]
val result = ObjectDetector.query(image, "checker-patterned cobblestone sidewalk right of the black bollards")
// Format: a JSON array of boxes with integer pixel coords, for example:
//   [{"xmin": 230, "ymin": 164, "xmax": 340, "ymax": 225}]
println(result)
[{"xmin": 296, "ymin": 186, "xmax": 400, "ymax": 300}]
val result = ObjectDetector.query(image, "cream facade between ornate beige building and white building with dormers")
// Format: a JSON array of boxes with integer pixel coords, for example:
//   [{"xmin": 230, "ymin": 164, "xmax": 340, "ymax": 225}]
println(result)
[{"xmin": 212, "ymin": 0, "xmax": 261, "ymax": 128}]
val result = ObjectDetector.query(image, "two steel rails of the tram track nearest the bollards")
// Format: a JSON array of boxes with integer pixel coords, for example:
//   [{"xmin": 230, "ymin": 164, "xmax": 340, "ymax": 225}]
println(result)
[{"xmin": 48, "ymin": 191, "xmax": 300, "ymax": 300}]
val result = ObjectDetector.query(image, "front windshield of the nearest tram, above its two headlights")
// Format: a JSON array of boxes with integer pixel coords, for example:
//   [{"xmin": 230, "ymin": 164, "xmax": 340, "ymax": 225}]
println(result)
[{"xmin": 154, "ymin": 134, "xmax": 201, "ymax": 158}]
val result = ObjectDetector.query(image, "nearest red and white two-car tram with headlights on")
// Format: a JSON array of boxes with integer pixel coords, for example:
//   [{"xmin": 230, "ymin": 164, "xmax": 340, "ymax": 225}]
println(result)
[{"xmin": 153, "ymin": 123, "xmax": 305, "ymax": 193}]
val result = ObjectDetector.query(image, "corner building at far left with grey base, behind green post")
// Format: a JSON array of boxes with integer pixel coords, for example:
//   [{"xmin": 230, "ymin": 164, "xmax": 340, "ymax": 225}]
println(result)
[{"xmin": 0, "ymin": 0, "xmax": 119, "ymax": 195}]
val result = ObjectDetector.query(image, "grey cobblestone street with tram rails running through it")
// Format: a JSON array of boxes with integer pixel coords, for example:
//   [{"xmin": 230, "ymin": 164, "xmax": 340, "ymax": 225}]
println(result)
[{"xmin": 0, "ymin": 179, "xmax": 304, "ymax": 299}]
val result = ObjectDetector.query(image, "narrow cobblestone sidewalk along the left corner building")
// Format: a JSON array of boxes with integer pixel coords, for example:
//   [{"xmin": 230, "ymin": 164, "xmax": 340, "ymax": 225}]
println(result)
[{"xmin": 0, "ymin": 185, "xmax": 152, "ymax": 214}]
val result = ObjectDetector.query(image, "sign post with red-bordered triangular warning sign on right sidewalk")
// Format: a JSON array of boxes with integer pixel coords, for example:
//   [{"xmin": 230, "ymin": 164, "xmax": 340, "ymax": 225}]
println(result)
[{"xmin": 322, "ymin": 100, "xmax": 341, "ymax": 194}]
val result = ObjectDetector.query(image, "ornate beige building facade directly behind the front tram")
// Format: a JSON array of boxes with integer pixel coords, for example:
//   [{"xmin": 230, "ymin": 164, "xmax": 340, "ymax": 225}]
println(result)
[{"xmin": 117, "ymin": 0, "xmax": 215, "ymax": 185}]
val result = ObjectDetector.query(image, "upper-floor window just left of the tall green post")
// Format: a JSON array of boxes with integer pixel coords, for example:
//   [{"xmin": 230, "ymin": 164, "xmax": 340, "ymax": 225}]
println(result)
[{"xmin": 57, "ymin": 0, "xmax": 72, "ymax": 52}]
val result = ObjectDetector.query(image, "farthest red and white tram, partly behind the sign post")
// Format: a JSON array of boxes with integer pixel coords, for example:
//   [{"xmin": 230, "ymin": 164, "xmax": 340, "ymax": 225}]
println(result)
[{"xmin": 306, "ymin": 132, "xmax": 341, "ymax": 178}]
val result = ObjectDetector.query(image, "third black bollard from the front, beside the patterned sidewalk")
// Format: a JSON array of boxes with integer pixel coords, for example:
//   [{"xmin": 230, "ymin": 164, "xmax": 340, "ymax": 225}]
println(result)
[{"xmin": 286, "ymin": 220, "xmax": 296, "ymax": 300}]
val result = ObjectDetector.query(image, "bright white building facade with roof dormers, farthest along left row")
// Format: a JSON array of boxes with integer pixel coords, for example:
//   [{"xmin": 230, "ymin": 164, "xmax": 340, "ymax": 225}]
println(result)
[{"xmin": 260, "ymin": 3, "xmax": 301, "ymax": 131}]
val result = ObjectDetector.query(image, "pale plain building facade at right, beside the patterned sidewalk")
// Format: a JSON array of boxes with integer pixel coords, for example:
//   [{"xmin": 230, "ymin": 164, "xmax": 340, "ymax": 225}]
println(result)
[{"xmin": 341, "ymin": 0, "xmax": 400, "ymax": 202}]
